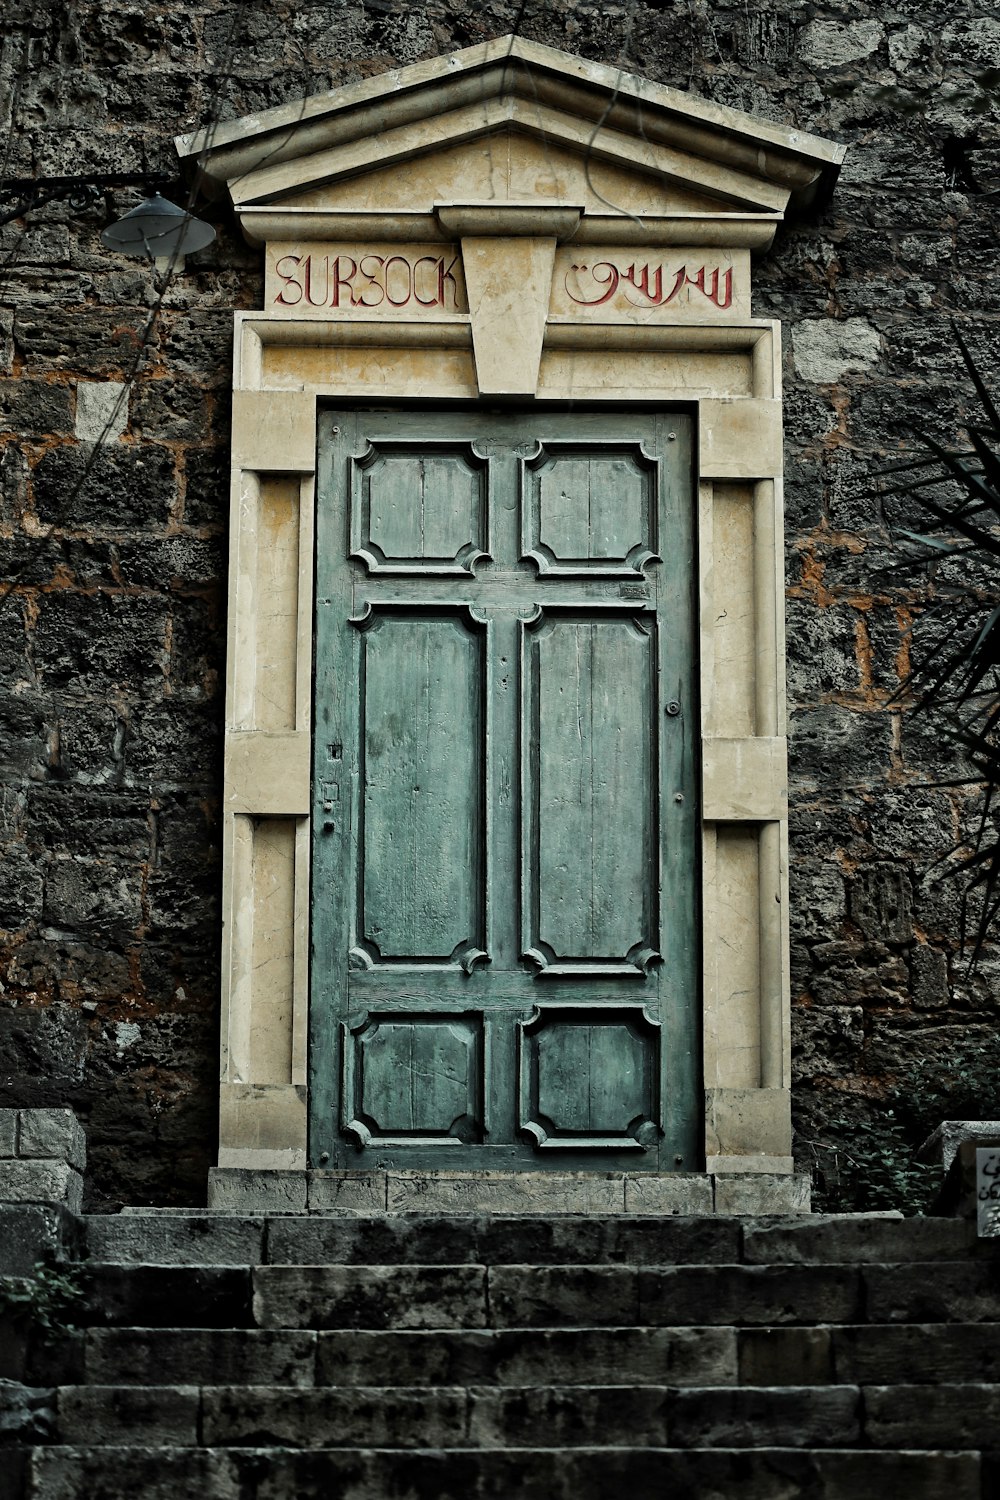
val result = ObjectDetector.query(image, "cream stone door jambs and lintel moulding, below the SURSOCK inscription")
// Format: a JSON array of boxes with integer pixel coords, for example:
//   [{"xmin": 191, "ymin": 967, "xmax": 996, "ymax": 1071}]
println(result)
[{"xmin": 219, "ymin": 304, "xmax": 792, "ymax": 1173}]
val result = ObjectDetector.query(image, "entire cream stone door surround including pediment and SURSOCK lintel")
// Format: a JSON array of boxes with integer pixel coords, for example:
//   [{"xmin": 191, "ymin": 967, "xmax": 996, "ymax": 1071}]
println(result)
[{"xmin": 178, "ymin": 39, "xmax": 843, "ymax": 1173}]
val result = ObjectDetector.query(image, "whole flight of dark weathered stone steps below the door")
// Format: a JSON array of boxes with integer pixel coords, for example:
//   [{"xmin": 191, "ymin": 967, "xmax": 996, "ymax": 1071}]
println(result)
[{"xmin": 0, "ymin": 1206, "xmax": 1000, "ymax": 1500}]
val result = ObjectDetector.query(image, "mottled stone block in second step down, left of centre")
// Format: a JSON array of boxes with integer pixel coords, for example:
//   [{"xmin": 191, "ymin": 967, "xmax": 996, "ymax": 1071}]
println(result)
[{"xmin": 253, "ymin": 1266, "xmax": 486, "ymax": 1329}]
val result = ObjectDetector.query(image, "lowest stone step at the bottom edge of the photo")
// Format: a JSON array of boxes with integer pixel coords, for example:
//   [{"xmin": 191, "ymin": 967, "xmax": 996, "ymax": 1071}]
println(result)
[{"xmin": 17, "ymin": 1446, "xmax": 990, "ymax": 1500}]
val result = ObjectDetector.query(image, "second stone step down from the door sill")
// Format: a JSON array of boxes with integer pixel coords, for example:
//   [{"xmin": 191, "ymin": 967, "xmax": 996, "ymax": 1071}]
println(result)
[{"xmin": 81, "ymin": 1262, "xmax": 1000, "ymax": 1329}]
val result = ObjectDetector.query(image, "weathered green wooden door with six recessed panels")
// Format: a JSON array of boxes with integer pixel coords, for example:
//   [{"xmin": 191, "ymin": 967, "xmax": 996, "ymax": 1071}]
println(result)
[{"xmin": 310, "ymin": 411, "xmax": 700, "ymax": 1172}]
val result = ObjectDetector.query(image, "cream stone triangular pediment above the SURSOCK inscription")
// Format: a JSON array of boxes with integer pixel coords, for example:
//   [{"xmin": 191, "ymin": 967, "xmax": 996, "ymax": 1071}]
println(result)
[{"xmin": 177, "ymin": 38, "xmax": 844, "ymax": 245}]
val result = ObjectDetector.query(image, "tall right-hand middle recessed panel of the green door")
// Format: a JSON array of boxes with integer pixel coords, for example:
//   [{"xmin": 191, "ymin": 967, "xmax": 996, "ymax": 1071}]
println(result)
[{"xmin": 522, "ymin": 605, "xmax": 660, "ymax": 974}]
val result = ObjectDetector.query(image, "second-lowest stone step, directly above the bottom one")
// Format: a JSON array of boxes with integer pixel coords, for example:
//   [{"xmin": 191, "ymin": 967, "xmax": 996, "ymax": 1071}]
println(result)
[{"xmin": 0, "ymin": 1386, "xmax": 869, "ymax": 1448}]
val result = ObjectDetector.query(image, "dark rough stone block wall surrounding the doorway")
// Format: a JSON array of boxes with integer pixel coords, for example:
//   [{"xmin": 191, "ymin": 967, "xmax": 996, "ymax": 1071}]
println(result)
[{"xmin": 0, "ymin": 0, "xmax": 1000, "ymax": 1206}]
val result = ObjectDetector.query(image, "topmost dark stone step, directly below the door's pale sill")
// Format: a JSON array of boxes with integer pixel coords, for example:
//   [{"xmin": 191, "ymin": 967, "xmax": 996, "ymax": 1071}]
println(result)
[{"xmin": 84, "ymin": 1211, "xmax": 1000, "ymax": 1266}]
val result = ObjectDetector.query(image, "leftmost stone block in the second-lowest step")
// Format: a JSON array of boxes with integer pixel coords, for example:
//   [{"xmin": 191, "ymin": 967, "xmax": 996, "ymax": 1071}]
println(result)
[{"xmin": 55, "ymin": 1386, "xmax": 199, "ymax": 1448}]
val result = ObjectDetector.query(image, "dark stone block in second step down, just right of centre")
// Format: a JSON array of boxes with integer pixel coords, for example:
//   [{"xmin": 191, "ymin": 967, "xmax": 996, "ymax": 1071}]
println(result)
[{"xmin": 489, "ymin": 1266, "xmax": 639, "ymax": 1328}]
